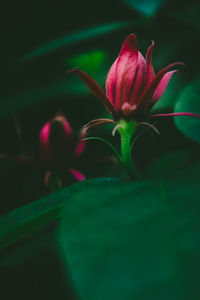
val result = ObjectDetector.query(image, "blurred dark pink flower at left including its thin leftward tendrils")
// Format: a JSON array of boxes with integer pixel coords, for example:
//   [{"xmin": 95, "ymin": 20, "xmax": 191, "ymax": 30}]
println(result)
[{"xmin": 0, "ymin": 112, "xmax": 85, "ymax": 191}]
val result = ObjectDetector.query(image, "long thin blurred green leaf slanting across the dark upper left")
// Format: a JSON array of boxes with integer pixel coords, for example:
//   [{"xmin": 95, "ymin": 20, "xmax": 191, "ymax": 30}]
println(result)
[{"xmin": 20, "ymin": 21, "xmax": 131, "ymax": 62}]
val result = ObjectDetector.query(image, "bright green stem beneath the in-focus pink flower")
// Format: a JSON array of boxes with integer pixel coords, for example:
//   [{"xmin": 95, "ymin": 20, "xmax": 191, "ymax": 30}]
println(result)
[{"xmin": 118, "ymin": 120, "xmax": 138, "ymax": 179}]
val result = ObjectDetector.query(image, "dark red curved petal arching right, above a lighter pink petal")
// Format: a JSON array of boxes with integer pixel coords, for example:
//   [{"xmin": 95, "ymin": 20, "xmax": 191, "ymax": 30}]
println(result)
[{"xmin": 138, "ymin": 62, "xmax": 182, "ymax": 114}]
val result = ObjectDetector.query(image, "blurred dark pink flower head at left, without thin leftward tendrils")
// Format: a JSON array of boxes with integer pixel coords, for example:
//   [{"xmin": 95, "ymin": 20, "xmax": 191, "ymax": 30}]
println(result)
[{"xmin": 39, "ymin": 113, "xmax": 85, "ymax": 183}]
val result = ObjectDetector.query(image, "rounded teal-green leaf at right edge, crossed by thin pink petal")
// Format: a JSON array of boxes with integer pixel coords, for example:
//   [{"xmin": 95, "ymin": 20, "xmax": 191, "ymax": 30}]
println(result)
[{"xmin": 175, "ymin": 77, "xmax": 200, "ymax": 142}]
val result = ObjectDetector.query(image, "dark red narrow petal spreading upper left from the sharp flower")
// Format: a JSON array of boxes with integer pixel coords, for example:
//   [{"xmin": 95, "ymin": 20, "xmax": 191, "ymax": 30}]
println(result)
[{"xmin": 67, "ymin": 68, "xmax": 115, "ymax": 114}]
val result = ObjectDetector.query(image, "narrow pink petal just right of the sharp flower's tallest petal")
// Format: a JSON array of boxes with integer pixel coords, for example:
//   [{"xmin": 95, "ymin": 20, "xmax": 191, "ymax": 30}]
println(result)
[{"xmin": 130, "ymin": 52, "xmax": 146, "ymax": 105}]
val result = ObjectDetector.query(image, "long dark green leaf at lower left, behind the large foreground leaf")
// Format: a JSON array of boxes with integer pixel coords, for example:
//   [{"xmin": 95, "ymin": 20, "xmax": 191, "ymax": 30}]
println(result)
[{"xmin": 0, "ymin": 178, "xmax": 117, "ymax": 249}]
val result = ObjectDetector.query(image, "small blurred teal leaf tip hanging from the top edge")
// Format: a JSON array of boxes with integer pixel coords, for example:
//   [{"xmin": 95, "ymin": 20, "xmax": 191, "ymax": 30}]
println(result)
[{"xmin": 125, "ymin": 0, "xmax": 165, "ymax": 17}]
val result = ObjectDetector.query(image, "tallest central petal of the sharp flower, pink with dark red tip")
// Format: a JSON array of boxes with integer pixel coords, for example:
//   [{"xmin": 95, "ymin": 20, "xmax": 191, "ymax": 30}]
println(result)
[{"xmin": 115, "ymin": 34, "xmax": 138, "ymax": 109}]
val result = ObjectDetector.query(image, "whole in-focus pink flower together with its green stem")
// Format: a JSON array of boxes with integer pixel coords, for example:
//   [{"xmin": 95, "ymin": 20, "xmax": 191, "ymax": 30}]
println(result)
[{"xmin": 69, "ymin": 34, "xmax": 200, "ymax": 177}]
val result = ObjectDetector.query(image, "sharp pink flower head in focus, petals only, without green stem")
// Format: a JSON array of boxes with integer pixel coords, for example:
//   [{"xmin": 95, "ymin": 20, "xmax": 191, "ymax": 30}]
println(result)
[{"xmin": 69, "ymin": 34, "xmax": 199, "ymax": 131}]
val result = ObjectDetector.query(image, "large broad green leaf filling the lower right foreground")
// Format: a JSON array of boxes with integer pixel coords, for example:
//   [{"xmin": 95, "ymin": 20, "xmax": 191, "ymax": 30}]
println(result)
[{"xmin": 60, "ymin": 166, "xmax": 200, "ymax": 300}]
